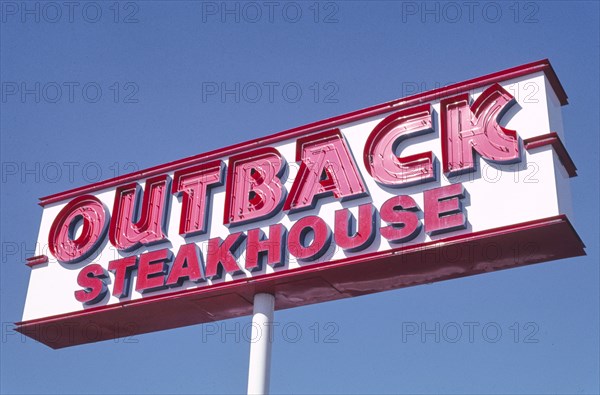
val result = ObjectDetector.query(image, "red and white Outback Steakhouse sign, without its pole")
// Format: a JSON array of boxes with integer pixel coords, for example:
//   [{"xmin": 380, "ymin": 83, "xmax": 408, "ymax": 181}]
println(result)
[{"xmin": 17, "ymin": 60, "xmax": 585, "ymax": 348}]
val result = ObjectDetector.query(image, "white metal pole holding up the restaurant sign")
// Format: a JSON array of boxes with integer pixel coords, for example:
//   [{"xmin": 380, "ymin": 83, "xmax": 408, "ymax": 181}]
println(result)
[{"xmin": 248, "ymin": 293, "xmax": 275, "ymax": 395}]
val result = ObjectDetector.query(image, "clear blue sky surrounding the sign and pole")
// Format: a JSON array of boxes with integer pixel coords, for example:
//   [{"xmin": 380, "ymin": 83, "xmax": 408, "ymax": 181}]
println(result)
[{"xmin": 0, "ymin": 1, "xmax": 600, "ymax": 394}]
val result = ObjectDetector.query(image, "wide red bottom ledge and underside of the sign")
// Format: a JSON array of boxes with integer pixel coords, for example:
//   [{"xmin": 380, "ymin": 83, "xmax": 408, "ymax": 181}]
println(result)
[{"xmin": 15, "ymin": 215, "xmax": 585, "ymax": 348}]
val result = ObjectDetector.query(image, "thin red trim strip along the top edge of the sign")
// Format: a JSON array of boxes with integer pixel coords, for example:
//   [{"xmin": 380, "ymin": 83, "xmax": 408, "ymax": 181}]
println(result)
[{"xmin": 39, "ymin": 59, "xmax": 568, "ymax": 206}]
